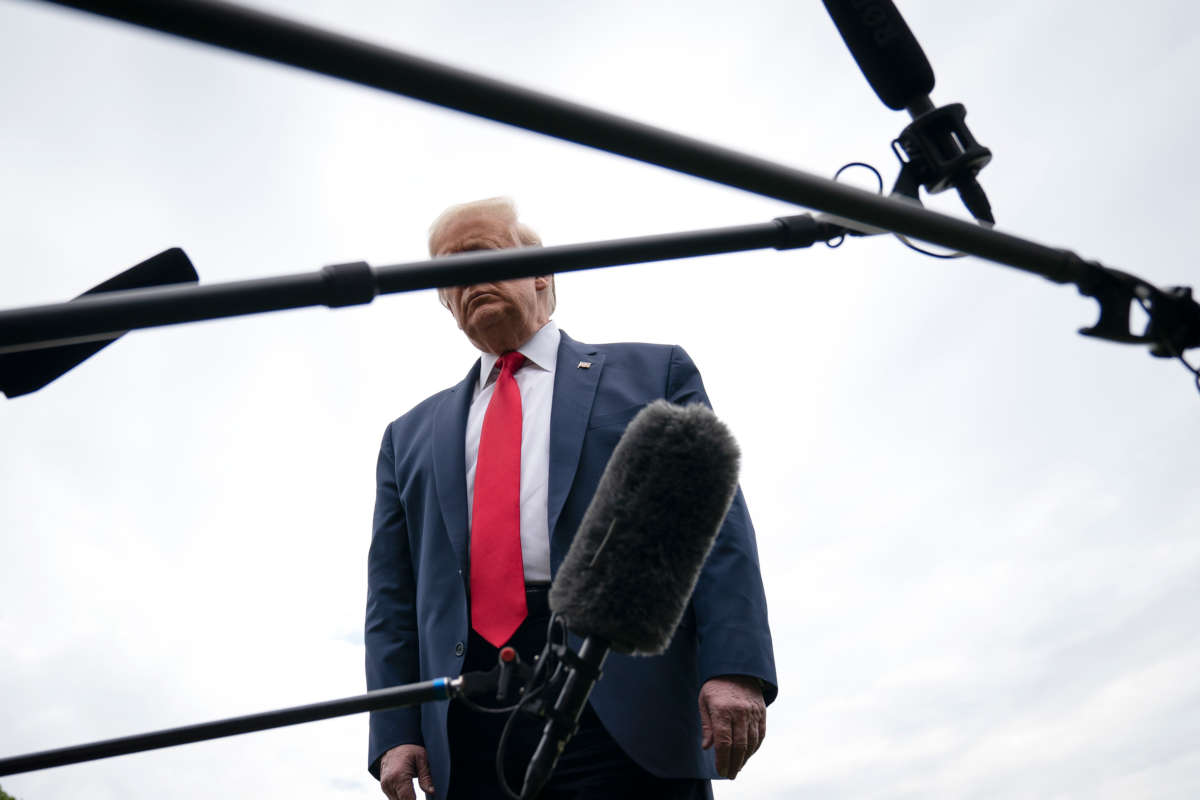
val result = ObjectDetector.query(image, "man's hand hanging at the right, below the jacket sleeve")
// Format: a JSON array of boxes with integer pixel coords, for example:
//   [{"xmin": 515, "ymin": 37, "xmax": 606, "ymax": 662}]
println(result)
[{"xmin": 700, "ymin": 675, "xmax": 767, "ymax": 778}]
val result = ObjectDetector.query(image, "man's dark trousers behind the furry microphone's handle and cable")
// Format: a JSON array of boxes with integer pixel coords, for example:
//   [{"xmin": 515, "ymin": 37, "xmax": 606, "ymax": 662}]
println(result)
[{"xmin": 448, "ymin": 588, "xmax": 713, "ymax": 800}]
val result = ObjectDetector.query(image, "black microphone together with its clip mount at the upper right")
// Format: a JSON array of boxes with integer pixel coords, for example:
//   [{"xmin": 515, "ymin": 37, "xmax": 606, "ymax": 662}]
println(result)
[{"xmin": 822, "ymin": 0, "xmax": 995, "ymax": 224}]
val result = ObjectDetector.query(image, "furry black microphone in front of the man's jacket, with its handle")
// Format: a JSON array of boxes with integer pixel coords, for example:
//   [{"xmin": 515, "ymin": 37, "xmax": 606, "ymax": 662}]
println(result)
[{"xmin": 521, "ymin": 401, "xmax": 740, "ymax": 798}]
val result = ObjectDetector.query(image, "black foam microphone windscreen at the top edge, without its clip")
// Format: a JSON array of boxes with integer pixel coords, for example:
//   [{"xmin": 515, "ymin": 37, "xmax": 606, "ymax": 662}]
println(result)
[{"xmin": 824, "ymin": 0, "xmax": 934, "ymax": 112}]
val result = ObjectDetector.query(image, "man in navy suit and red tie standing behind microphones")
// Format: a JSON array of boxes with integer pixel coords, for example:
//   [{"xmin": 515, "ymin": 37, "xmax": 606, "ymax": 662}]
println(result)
[{"xmin": 366, "ymin": 198, "xmax": 776, "ymax": 800}]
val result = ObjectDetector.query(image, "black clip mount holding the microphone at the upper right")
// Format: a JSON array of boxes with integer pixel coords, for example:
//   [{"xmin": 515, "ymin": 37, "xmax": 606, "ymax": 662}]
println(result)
[{"xmin": 892, "ymin": 97, "xmax": 995, "ymax": 224}]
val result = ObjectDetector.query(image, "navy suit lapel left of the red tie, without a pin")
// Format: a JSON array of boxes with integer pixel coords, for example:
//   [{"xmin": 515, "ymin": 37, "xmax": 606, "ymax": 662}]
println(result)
[{"xmin": 433, "ymin": 361, "xmax": 479, "ymax": 575}]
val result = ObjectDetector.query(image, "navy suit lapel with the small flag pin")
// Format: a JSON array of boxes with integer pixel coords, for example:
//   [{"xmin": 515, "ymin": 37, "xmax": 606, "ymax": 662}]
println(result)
[{"xmin": 546, "ymin": 333, "xmax": 604, "ymax": 551}]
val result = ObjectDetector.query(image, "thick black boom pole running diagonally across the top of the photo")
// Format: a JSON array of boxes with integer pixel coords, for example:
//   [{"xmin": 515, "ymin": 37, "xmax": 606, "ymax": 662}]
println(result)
[{"xmin": 37, "ymin": 0, "xmax": 1079, "ymax": 283}]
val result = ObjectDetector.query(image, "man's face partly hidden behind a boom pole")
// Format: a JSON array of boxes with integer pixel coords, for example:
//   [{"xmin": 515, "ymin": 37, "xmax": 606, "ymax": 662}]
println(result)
[{"xmin": 433, "ymin": 213, "xmax": 550, "ymax": 354}]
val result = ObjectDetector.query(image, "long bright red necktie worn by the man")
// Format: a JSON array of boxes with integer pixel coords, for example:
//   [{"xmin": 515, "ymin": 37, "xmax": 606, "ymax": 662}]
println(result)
[{"xmin": 470, "ymin": 353, "xmax": 528, "ymax": 646}]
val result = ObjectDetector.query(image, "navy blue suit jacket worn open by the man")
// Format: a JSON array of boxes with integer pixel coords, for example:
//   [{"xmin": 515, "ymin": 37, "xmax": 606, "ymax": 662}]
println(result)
[{"xmin": 366, "ymin": 333, "xmax": 776, "ymax": 796}]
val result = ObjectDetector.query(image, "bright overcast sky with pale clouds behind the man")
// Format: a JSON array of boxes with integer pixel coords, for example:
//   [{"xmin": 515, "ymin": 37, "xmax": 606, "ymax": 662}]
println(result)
[{"xmin": 0, "ymin": 0, "xmax": 1200, "ymax": 800}]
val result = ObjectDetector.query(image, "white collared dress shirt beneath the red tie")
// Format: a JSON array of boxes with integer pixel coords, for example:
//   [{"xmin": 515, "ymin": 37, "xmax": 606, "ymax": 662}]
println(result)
[{"xmin": 467, "ymin": 321, "xmax": 562, "ymax": 583}]
